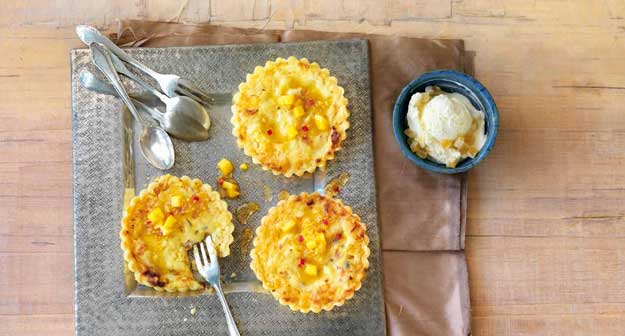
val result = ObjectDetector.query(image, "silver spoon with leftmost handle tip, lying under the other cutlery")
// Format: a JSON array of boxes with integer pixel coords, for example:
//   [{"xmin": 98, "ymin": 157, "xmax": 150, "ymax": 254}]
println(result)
[{"xmin": 80, "ymin": 71, "xmax": 208, "ymax": 141}]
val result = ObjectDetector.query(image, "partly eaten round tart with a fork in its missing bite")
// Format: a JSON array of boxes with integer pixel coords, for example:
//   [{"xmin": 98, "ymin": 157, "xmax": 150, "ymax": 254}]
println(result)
[{"xmin": 120, "ymin": 175, "xmax": 234, "ymax": 292}]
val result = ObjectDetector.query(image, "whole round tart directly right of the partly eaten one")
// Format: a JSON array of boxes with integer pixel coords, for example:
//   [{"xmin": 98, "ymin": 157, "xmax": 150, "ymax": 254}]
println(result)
[{"xmin": 251, "ymin": 193, "xmax": 370, "ymax": 313}]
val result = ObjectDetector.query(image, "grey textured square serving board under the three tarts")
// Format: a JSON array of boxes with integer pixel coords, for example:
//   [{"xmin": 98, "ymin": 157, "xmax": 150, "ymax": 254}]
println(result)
[{"xmin": 71, "ymin": 40, "xmax": 386, "ymax": 335}]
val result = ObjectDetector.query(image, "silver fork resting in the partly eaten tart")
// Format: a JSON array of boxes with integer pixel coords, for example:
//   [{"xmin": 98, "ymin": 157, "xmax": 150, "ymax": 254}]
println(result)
[{"xmin": 193, "ymin": 236, "xmax": 239, "ymax": 336}]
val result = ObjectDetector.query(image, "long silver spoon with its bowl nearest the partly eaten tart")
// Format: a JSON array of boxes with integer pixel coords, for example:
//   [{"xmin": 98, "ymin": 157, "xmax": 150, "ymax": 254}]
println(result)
[{"xmin": 89, "ymin": 43, "xmax": 175, "ymax": 169}]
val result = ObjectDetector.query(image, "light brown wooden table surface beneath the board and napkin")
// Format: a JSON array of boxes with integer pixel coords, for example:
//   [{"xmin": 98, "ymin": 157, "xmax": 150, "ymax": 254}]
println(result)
[{"xmin": 0, "ymin": 0, "xmax": 625, "ymax": 336}]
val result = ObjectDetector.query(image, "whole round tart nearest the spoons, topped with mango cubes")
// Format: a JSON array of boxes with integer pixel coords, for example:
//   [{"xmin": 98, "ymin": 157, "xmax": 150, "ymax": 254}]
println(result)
[{"xmin": 231, "ymin": 57, "xmax": 349, "ymax": 177}]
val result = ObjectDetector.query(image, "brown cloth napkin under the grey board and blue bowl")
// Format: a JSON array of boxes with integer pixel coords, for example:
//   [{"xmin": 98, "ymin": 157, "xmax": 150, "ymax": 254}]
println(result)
[{"xmin": 113, "ymin": 21, "xmax": 470, "ymax": 335}]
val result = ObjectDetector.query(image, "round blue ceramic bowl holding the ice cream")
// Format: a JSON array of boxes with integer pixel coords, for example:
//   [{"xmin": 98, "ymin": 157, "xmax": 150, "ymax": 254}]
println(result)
[{"xmin": 393, "ymin": 70, "xmax": 499, "ymax": 174}]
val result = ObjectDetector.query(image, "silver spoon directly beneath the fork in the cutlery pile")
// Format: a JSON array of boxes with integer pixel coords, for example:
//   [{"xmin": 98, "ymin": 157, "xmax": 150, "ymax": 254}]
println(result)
[{"xmin": 111, "ymin": 54, "xmax": 210, "ymax": 132}]
